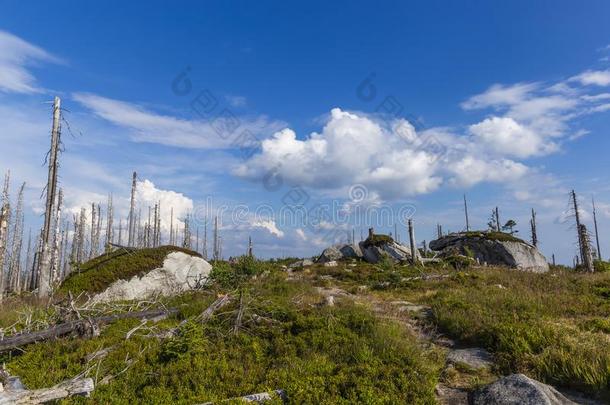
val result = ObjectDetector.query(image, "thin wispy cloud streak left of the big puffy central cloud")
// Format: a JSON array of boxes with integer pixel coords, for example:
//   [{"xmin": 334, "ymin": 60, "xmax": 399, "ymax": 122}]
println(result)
[{"xmin": 72, "ymin": 93, "xmax": 283, "ymax": 149}]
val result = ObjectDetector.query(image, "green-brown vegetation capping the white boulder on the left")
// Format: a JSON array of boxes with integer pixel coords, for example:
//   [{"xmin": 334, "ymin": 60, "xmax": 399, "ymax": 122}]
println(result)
[{"xmin": 59, "ymin": 246, "xmax": 201, "ymax": 295}]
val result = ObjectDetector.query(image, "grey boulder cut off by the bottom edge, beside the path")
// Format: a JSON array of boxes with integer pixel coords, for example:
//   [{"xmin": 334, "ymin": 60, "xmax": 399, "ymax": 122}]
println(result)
[{"xmin": 472, "ymin": 374, "xmax": 576, "ymax": 405}]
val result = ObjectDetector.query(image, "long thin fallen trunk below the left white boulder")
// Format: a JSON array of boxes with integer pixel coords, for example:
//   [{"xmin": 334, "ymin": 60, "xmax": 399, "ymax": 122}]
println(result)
[{"xmin": 0, "ymin": 309, "xmax": 178, "ymax": 353}]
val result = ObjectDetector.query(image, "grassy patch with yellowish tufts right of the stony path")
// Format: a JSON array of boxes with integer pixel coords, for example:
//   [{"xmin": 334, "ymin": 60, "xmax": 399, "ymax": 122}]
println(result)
[{"xmin": 394, "ymin": 268, "xmax": 610, "ymax": 395}]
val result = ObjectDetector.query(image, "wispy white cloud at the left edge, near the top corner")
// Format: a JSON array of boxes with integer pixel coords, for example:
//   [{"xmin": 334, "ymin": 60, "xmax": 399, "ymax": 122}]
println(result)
[{"xmin": 0, "ymin": 31, "xmax": 61, "ymax": 93}]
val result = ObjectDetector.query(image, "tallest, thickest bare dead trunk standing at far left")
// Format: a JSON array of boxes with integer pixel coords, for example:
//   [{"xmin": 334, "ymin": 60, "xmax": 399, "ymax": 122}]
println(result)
[{"xmin": 38, "ymin": 97, "xmax": 61, "ymax": 298}]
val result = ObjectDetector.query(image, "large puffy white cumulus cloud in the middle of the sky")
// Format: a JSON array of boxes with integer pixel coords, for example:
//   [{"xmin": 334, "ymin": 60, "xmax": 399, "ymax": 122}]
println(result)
[{"xmin": 234, "ymin": 108, "xmax": 526, "ymax": 200}]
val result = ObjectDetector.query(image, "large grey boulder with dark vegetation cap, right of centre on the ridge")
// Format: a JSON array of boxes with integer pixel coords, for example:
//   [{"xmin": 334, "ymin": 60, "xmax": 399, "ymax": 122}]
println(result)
[{"xmin": 429, "ymin": 232, "xmax": 549, "ymax": 273}]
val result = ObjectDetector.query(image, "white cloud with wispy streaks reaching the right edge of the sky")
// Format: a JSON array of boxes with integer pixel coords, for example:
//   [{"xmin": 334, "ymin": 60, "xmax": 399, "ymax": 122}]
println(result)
[{"xmin": 461, "ymin": 71, "xmax": 610, "ymax": 159}]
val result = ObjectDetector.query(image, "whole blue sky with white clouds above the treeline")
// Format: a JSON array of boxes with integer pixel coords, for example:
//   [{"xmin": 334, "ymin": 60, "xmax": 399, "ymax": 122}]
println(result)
[{"xmin": 0, "ymin": 1, "xmax": 610, "ymax": 263}]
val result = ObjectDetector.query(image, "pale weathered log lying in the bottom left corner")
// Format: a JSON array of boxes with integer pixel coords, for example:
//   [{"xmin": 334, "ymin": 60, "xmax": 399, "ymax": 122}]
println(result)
[{"xmin": 0, "ymin": 378, "xmax": 95, "ymax": 405}]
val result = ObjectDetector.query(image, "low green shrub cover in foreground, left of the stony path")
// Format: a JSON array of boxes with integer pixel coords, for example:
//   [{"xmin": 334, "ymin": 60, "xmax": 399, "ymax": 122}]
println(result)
[{"xmin": 0, "ymin": 269, "xmax": 443, "ymax": 404}]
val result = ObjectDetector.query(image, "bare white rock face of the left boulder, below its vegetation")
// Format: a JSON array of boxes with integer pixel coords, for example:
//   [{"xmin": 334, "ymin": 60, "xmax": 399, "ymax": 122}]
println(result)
[{"xmin": 93, "ymin": 252, "xmax": 212, "ymax": 302}]
